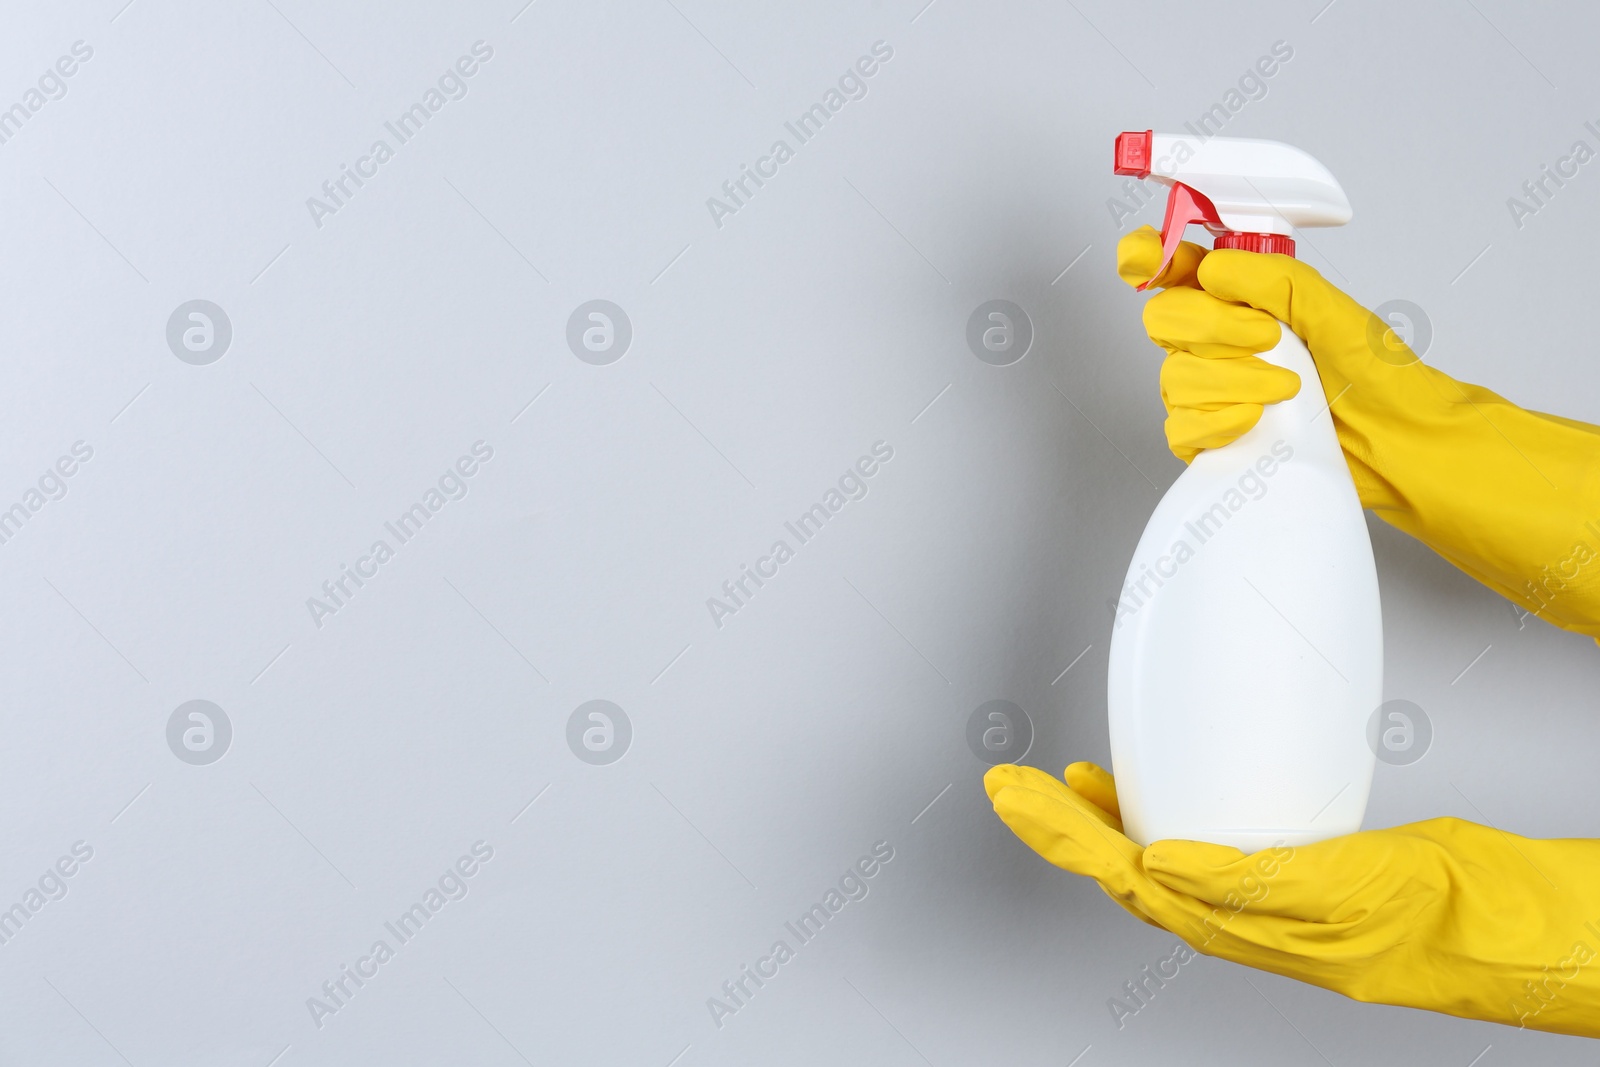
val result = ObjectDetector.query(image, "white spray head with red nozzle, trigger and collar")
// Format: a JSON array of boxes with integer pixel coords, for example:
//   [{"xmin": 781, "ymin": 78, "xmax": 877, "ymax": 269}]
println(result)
[{"xmin": 1115, "ymin": 130, "xmax": 1350, "ymax": 288}]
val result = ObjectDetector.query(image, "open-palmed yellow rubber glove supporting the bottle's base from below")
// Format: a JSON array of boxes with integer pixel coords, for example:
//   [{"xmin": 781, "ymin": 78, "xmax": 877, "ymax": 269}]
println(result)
[{"xmin": 984, "ymin": 763, "xmax": 1600, "ymax": 1037}]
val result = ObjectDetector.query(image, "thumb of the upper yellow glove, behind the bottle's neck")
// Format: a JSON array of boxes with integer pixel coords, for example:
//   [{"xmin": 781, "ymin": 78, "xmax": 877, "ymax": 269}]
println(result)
[{"xmin": 1195, "ymin": 248, "xmax": 1416, "ymax": 379}]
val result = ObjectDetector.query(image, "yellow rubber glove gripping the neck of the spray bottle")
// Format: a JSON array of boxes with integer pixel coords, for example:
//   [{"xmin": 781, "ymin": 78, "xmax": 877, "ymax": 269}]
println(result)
[{"xmin": 1117, "ymin": 227, "xmax": 1600, "ymax": 638}]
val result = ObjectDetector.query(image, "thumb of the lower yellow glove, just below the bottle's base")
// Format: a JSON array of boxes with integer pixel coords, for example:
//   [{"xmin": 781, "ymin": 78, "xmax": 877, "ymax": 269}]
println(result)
[{"xmin": 1144, "ymin": 833, "xmax": 1392, "ymax": 923}]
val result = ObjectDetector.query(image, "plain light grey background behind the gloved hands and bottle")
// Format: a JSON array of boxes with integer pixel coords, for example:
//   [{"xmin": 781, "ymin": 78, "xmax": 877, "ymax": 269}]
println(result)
[{"xmin": 0, "ymin": 0, "xmax": 1600, "ymax": 1067}]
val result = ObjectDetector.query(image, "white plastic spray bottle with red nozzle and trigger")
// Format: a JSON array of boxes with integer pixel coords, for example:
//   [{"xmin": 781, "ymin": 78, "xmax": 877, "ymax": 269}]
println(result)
[{"xmin": 1107, "ymin": 131, "xmax": 1382, "ymax": 853}]
